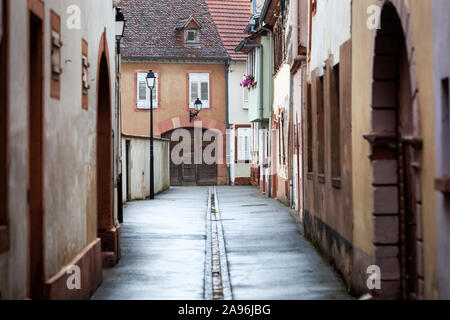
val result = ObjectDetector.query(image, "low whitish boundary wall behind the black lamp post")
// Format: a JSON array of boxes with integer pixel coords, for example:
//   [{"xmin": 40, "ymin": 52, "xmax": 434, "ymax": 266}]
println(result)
[{"xmin": 122, "ymin": 136, "xmax": 170, "ymax": 203}]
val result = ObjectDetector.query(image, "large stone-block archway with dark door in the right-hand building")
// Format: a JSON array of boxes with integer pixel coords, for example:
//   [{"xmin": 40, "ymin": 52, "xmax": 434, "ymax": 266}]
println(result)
[{"xmin": 365, "ymin": 0, "xmax": 423, "ymax": 299}]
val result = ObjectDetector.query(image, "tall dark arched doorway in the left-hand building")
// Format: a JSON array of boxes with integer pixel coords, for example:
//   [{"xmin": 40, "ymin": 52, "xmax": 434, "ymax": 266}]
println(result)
[{"xmin": 97, "ymin": 52, "xmax": 115, "ymax": 252}]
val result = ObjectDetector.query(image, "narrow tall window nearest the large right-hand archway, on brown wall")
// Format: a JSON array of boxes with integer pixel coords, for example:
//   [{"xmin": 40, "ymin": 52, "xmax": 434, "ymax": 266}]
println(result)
[{"xmin": 330, "ymin": 64, "xmax": 341, "ymax": 178}]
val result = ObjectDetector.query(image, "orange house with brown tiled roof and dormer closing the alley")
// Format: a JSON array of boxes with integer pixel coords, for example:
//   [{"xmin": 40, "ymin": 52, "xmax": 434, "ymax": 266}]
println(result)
[{"xmin": 121, "ymin": 0, "xmax": 230, "ymax": 193}]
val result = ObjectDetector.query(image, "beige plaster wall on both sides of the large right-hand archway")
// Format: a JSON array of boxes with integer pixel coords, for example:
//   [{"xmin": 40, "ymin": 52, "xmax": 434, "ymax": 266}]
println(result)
[{"xmin": 352, "ymin": 0, "xmax": 437, "ymax": 299}]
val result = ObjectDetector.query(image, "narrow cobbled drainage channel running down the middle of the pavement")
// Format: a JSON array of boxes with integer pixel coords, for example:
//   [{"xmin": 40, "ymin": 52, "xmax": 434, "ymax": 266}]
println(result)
[{"xmin": 205, "ymin": 187, "xmax": 233, "ymax": 300}]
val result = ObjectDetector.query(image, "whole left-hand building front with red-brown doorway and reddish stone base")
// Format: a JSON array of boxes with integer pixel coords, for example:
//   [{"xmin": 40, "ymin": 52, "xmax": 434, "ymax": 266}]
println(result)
[{"xmin": 0, "ymin": 0, "xmax": 120, "ymax": 299}]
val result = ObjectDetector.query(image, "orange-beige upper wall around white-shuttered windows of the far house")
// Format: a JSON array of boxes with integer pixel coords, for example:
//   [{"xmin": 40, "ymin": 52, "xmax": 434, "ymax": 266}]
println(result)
[{"xmin": 121, "ymin": 59, "xmax": 226, "ymax": 136}]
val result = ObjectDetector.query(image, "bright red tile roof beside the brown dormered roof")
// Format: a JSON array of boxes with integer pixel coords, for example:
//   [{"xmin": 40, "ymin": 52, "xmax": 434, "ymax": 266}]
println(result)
[{"xmin": 206, "ymin": 0, "xmax": 251, "ymax": 60}]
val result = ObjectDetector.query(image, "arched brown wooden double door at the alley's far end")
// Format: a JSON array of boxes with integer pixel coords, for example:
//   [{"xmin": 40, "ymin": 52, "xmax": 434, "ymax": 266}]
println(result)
[{"xmin": 162, "ymin": 128, "xmax": 220, "ymax": 186}]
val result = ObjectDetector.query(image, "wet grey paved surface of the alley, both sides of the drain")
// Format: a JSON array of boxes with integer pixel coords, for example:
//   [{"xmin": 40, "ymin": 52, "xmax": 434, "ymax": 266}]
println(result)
[{"xmin": 93, "ymin": 186, "xmax": 351, "ymax": 300}]
